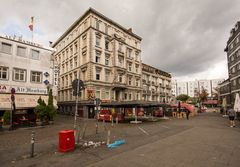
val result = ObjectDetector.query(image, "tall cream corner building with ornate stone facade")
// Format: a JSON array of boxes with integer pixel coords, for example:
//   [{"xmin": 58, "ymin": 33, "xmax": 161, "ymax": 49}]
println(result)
[{"xmin": 53, "ymin": 8, "xmax": 142, "ymax": 117}]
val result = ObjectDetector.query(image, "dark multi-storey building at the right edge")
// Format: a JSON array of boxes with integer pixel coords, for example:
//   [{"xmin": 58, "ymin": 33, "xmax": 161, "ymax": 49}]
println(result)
[{"xmin": 220, "ymin": 21, "xmax": 240, "ymax": 105}]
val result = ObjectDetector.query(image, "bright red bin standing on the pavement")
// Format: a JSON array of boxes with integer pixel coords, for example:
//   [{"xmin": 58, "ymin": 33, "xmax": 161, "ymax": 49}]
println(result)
[{"xmin": 58, "ymin": 130, "xmax": 74, "ymax": 152}]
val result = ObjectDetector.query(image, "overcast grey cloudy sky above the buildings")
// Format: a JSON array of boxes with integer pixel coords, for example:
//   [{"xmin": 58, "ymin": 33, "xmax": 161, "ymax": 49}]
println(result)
[{"xmin": 0, "ymin": 0, "xmax": 240, "ymax": 80}]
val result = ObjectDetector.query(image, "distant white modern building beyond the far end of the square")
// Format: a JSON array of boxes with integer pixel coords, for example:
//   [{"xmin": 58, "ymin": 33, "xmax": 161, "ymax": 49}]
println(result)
[{"xmin": 172, "ymin": 79, "xmax": 224, "ymax": 97}]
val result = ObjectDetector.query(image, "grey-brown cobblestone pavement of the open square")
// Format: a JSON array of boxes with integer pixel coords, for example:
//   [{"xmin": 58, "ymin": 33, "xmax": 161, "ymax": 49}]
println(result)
[{"xmin": 0, "ymin": 113, "xmax": 240, "ymax": 167}]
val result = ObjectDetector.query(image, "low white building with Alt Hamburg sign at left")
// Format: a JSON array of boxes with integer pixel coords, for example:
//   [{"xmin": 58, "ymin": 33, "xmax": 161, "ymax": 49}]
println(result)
[{"xmin": 0, "ymin": 36, "xmax": 53, "ymax": 115}]
